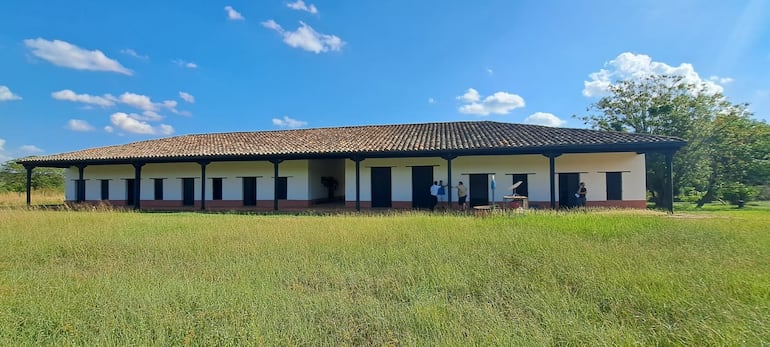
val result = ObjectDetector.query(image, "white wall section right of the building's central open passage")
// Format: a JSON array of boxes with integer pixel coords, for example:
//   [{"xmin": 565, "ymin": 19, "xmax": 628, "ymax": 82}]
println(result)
[{"xmin": 345, "ymin": 153, "xmax": 645, "ymax": 205}]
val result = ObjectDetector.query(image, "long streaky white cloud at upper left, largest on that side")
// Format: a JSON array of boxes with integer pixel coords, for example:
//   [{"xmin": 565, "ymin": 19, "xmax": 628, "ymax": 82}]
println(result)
[{"xmin": 24, "ymin": 38, "xmax": 133, "ymax": 76}]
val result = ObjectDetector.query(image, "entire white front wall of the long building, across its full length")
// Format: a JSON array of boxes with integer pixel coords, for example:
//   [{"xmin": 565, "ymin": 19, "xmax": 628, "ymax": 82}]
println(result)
[{"xmin": 65, "ymin": 152, "xmax": 646, "ymax": 201}]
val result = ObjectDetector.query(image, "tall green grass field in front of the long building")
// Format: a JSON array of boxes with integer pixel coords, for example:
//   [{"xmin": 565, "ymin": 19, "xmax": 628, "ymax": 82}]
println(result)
[{"xmin": 0, "ymin": 206, "xmax": 770, "ymax": 346}]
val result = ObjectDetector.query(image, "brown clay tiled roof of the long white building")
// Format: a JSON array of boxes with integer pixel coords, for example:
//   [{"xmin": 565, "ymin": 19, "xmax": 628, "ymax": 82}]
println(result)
[{"xmin": 19, "ymin": 121, "xmax": 684, "ymax": 164}]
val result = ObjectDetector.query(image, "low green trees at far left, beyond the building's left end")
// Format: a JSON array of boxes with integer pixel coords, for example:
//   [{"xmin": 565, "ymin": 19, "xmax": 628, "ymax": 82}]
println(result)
[{"xmin": 0, "ymin": 161, "xmax": 64, "ymax": 193}]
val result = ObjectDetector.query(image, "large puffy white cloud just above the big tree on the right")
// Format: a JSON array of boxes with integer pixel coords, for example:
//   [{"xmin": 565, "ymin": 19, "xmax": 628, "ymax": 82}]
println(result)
[{"xmin": 583, "ymin": 52, "xmax": 732, "ymax": 97}]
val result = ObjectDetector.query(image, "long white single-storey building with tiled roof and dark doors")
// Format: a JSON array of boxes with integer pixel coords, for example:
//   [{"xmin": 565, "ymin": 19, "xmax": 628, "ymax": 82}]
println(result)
[{"xmin": 19, "ymin": 121, "xmax": 685, "ymax": 210}]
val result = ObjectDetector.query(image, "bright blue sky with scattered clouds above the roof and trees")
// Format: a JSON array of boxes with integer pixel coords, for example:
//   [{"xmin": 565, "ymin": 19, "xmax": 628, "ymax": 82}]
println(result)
[{"xmin": 0, "ymin": 0, "xmax": 770, "ymax": 161}]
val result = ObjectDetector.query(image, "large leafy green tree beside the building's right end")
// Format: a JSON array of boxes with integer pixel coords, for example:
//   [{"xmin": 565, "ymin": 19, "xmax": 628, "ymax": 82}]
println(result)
[{"xmin": 576, "ymin": 75, "xmax": 770, "ymax": 205}]
